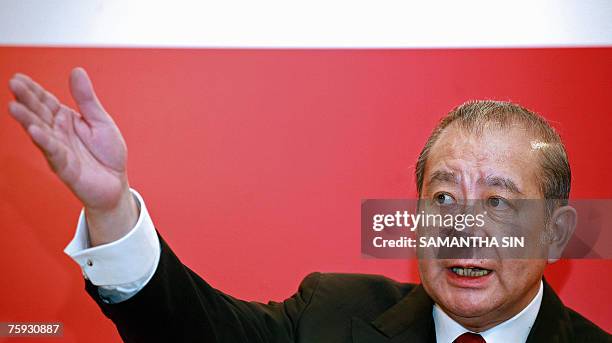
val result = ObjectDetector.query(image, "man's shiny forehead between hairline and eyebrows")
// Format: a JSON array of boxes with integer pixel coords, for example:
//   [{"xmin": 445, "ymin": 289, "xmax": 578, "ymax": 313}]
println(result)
[{"xmin": 424, "ymin": 124, "xmax": 539, "ymax": 196}]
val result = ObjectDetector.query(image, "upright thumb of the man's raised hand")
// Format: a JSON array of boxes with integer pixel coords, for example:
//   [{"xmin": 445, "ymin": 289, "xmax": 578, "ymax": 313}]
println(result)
[{"xmin": 70, "ymin": 67, "xmax": 108, "ymax": 124}]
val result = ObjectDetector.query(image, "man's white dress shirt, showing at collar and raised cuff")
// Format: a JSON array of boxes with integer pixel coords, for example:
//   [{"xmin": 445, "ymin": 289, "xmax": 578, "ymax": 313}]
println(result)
[{"xmin": 64, "ymin": 189, "xmax": 543, "ymax": 343}]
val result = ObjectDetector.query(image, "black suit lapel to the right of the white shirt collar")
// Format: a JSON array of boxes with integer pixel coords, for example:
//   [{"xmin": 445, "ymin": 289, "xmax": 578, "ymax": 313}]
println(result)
[{"xmin": 527, "ymin": 280, "xmax": 574, "ymax": 343}]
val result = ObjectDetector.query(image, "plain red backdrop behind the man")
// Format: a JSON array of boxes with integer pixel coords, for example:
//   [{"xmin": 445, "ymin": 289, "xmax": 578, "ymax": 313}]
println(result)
[{"xmin": 0, "ymin": 47, "xmax": 612, "ymax": 342}]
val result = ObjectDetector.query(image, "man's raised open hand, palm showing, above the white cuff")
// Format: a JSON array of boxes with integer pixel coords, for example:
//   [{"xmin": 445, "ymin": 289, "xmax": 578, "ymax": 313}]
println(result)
[{"xmin": 9, "ymin": 68, "xmax": 138, "ymax": 245}]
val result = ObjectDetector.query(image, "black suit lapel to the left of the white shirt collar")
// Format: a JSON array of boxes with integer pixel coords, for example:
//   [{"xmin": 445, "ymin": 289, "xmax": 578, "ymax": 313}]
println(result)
[{"xmin": 352, "ymin": 285, "xmax": 435, "ymax": 343}]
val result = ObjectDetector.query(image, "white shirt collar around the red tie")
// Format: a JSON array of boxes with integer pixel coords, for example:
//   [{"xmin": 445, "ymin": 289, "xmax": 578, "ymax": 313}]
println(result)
[{"xmin": 433, "ymin": 280, "xmax": 544, "ymax": 343}]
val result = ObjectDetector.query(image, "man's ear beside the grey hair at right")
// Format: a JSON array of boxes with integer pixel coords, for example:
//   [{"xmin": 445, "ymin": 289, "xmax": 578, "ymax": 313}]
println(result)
[{"xmin": 548, "ymin": 206, "xmax": 578, "ymax": 263}]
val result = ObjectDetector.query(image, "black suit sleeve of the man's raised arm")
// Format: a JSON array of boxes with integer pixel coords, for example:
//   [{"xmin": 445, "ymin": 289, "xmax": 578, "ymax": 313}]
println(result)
[{"xmin": 85, "ymin": 237, "xmax": 320, "ymax": 343}]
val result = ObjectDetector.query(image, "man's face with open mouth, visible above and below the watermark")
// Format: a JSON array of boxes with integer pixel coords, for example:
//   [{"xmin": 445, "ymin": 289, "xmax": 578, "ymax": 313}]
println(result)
[{"xmin": 419, "ymin": 124, "xmax": 546, "ymax": 331}]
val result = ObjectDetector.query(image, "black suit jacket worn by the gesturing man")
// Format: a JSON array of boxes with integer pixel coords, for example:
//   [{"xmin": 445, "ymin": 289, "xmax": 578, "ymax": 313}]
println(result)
[{"xmin": 86, "ymin": 237, "xmax": 611, "ymax": 343}]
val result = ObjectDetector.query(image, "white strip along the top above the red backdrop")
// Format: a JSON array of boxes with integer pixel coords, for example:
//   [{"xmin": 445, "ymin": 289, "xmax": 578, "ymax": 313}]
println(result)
[{"xmin": 0, "ymin": 0, "xmax": 612, "ymax": 48}]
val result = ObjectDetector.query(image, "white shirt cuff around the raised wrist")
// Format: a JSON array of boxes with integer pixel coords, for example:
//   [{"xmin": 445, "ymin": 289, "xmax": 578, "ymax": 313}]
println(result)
[{"xmin": 64, "ymin": 189, "xmax": 161, "ymax": 288}]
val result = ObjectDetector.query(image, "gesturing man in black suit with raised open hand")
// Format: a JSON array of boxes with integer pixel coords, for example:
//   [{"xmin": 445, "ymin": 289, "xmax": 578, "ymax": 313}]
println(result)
[{"xmin": 9, "ymin": 68, "xmax": 610, "ymax": 343}]
